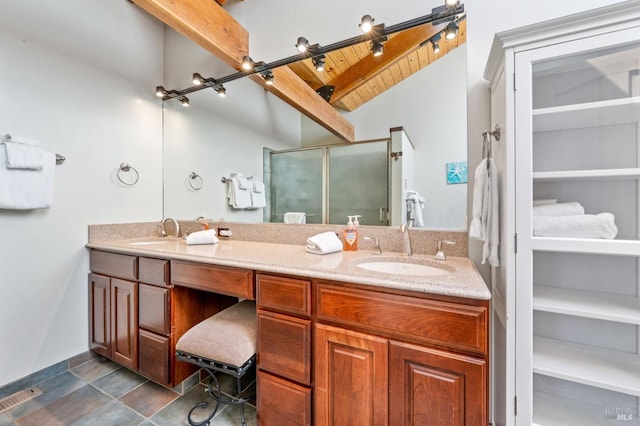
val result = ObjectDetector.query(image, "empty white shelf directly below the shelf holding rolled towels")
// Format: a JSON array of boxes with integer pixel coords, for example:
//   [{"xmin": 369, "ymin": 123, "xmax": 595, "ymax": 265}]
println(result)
[{"xmin": 533, "ymin": 285, "xmax": 640, "ymax": 325}]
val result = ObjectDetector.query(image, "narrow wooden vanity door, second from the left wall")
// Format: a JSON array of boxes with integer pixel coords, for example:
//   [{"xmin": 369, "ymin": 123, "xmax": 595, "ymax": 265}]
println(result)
[{"xmin": 111, "ymin": 278, "xmax": 138, "ymax": 370}]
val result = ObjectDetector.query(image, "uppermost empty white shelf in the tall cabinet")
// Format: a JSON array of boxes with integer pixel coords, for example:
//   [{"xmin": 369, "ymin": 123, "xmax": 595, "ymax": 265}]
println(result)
[{"xmin": 533, "ymin": 96, "xmax": 640, "ymax": 132}]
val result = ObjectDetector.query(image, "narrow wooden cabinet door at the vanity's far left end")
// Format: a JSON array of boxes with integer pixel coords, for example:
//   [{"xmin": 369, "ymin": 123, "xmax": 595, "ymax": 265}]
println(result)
[{"xmin": 89, "ymin": 274, "xmax": 111, "ymax": 357}]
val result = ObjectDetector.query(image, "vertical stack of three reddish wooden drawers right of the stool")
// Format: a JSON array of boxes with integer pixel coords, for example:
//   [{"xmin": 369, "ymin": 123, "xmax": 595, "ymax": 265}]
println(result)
[{"xmin": 256, "ymin": 273, "xmax": 312, "ymax": 425}]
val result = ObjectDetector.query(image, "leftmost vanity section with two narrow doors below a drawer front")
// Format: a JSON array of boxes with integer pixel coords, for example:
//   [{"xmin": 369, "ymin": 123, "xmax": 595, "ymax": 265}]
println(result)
[{"xmin": 89, "ymin": 251, "xmax": 138, "ymax": 370}]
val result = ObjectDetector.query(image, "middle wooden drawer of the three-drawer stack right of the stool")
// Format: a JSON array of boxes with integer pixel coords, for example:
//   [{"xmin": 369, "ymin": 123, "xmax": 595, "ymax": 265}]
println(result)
[{"xmin": 258, "ymin": 310, "xmax": 311, "ymax": 385}]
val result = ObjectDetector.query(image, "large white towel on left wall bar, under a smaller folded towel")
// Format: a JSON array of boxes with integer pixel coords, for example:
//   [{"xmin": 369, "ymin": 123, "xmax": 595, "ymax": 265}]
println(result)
[{"xmin": 0, "ymin": 149, "xmax": 56, "ymax": 210}]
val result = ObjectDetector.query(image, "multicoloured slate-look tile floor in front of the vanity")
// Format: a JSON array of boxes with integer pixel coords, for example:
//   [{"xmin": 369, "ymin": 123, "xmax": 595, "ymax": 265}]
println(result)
[{"xmin": 0, "ymin": 357, "xmax": 257, "ymax": 426}]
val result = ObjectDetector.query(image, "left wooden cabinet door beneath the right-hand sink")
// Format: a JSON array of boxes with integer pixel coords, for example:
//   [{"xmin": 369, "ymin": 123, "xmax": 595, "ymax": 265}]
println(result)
[{"xmin": 314, "ymin": 324, "xmax": 388, "ymax": 426}]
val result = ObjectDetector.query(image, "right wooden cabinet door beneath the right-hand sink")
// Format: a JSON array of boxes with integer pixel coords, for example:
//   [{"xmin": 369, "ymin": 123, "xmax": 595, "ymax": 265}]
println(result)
[{"xmin": 389, "ymin": 341, "xmax": 489, "ymax": 426}]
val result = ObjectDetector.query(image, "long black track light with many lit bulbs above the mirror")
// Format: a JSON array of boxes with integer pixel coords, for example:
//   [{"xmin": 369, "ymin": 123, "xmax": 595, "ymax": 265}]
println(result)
[{"xmin": 156, "ymin": 5, "xmax": 464, "ymax": 107}]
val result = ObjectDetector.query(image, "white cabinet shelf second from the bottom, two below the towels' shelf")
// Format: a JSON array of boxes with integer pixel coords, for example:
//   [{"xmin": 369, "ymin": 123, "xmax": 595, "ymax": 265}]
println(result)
[{"xmin": 533, "ymin": 336, "xmax": 640, "ymax": 396}]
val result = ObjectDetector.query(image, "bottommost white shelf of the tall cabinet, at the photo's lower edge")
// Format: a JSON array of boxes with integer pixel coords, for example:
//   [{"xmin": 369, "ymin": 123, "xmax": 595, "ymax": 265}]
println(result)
[{"xmin": 533, "ymin": 392, "xmax": 640, "ymax": 426}]
